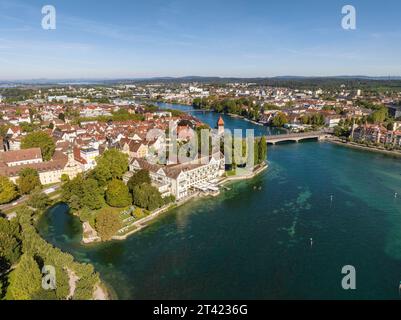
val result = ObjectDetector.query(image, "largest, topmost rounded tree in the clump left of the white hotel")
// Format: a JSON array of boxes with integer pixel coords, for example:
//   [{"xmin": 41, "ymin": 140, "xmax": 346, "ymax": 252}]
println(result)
[{"xmin": 92, "ymin": 149, "xmax": 128, "ymax": 186}]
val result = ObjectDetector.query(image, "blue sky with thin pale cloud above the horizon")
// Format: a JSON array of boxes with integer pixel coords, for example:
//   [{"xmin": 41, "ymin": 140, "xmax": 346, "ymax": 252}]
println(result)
[{"xmin": 0, "ymin": 0, "xmax": 401, "ymax": 80}]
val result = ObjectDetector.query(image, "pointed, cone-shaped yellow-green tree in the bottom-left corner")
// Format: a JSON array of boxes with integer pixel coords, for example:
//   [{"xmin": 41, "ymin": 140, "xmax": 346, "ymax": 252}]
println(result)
[{"xmin": 6, "ymin": 253, "xmax": 42, "ymax": 300}]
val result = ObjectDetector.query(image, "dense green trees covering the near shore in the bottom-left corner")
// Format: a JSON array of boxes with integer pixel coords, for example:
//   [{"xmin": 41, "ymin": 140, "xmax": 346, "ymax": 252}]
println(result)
[{"xmin": 0, "ymin": 207, "xmax": 100, "ymax": 300}]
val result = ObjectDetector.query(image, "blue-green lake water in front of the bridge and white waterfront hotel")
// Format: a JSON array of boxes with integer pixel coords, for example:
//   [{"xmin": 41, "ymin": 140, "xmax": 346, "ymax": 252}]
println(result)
[{"xmin": 39, "ymin": 107, "xmax": 401, "ymax": 299}]
